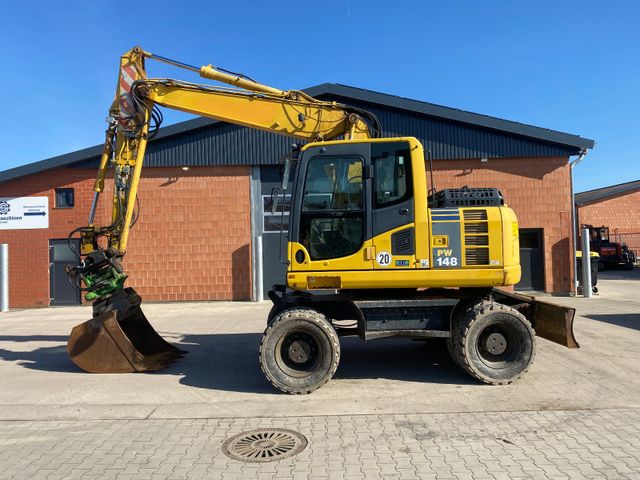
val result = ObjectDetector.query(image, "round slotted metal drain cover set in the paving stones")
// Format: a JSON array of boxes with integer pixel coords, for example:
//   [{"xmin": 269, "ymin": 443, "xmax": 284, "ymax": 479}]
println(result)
[{"xmin": 222, "ymin": 428, "xmax": 307, "ymax": 462}]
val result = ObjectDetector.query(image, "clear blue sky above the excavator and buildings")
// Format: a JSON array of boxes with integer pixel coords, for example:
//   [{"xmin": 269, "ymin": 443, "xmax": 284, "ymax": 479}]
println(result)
[{"xmin": 0, "ymin": 0, "xmax": 640, "ymax": 191}]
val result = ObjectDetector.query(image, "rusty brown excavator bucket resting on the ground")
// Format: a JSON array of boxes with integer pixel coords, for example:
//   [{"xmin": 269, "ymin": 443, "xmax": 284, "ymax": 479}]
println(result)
[{"xmin": 67, "ymin": 288, "xmax": 186, "ymax": 373}]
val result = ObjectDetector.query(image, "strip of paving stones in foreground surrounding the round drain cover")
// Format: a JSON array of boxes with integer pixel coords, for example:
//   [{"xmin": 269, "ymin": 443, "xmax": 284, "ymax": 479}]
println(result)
[{"xmin": 0, "ymin": 409, "xmax": 640, "ymax": 480}]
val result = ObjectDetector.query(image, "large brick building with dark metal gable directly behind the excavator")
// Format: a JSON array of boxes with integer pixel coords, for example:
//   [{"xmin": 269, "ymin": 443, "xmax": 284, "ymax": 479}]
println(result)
[{"xmin": 0, "ymin": 84, "xmax": 593, "ymax": 307}]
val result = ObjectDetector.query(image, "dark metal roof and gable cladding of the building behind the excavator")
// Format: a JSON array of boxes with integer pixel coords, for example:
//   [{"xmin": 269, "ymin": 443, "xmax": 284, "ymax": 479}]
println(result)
[{"xmin": 0, "ymin": 83, "xmax": 594, "ymax": 182}]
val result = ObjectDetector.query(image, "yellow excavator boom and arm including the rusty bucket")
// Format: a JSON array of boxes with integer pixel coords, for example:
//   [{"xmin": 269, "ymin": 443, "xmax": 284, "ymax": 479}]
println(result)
[{"xmin": 67, "ymin": 47, "xmax": 380, "ymax": 373}]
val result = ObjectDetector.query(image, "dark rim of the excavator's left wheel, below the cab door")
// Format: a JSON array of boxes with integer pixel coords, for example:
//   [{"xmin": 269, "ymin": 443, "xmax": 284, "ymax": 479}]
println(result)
[{"xmin": 276, "ymin": 330, "xmax": 323, "ymax": 377}]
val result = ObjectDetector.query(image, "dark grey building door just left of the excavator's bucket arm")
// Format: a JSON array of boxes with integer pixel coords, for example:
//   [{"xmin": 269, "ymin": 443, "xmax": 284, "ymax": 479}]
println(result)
[{"xmin": 49, "ymin": 238, "xmax": 80, "ymax": 306}]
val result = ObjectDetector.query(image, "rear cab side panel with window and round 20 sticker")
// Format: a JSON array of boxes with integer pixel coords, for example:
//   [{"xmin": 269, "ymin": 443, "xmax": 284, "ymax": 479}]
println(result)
[{"xmin": 371, "ymin": 141, "xmax": 416, "ymax": 269}]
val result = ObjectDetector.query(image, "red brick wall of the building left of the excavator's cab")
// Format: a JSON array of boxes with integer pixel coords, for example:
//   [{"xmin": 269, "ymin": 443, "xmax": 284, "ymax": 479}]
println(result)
[{"xmin": 0, "ymin": 167, "xmax": 251, "ymax": 307}]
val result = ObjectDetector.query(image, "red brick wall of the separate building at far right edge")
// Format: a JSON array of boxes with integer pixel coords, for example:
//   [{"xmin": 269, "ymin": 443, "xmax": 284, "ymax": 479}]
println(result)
[{"xmin": 578, "ymin": 190, "xmax": 640, "ymax": 251}]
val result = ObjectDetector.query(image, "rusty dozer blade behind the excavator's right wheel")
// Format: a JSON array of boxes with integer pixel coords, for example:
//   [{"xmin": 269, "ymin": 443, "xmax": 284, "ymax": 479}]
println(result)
[{"xmin": 493, "ymin": 289, "xmax": 580, "ymax": 348}]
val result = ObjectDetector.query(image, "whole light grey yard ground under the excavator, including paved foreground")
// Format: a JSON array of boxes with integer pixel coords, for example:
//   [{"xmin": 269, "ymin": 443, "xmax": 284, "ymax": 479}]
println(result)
[{"xmin": 0, "ymin": 271, "xmax": 640, "ymax": 480}]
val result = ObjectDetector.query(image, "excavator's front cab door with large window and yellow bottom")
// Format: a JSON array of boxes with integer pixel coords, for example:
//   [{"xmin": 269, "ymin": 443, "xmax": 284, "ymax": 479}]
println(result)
[{"xmin": 289, "ymin": 142, "xmax": 372, "ymax": 272}]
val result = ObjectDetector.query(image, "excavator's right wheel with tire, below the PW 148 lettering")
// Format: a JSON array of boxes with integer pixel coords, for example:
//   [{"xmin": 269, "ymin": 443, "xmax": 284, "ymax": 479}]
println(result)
[{"xmin": 451, "ymin": 301, "xmax": 536, "ymax": 385}]
